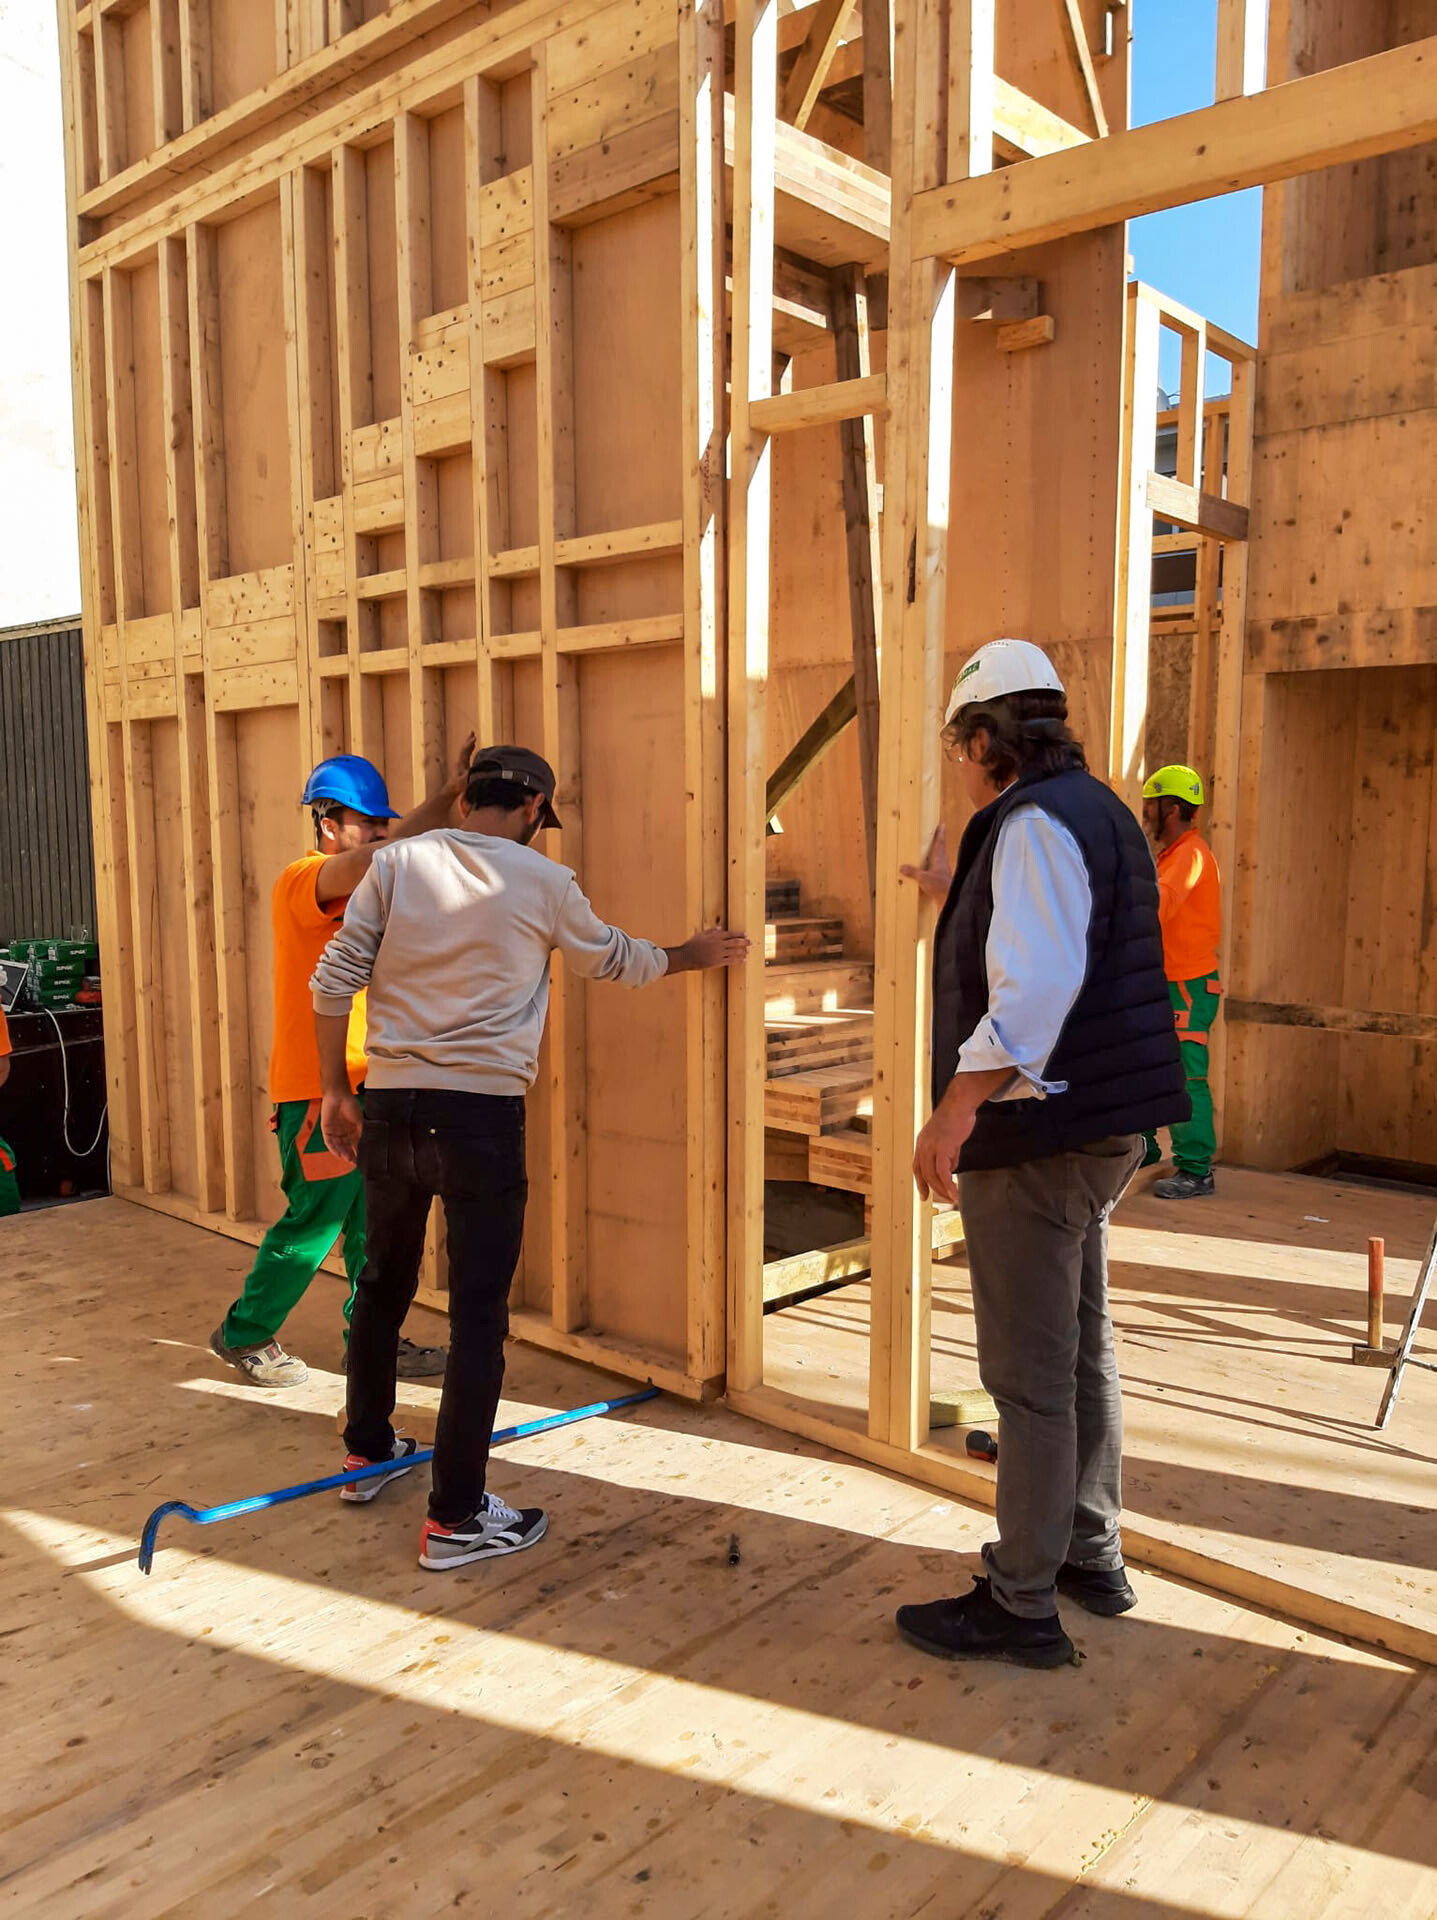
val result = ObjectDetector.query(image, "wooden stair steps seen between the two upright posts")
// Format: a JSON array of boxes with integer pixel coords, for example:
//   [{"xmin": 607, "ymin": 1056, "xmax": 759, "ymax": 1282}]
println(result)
[{"xmin": 763, "ymin": 879, "xmax": 874, "ymax": 1194}]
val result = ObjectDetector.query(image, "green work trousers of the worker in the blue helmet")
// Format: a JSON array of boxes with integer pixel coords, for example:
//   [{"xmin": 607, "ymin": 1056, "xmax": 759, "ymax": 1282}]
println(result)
[{"xmin": 219, "ymin": 1100, "xmax": 365, "ymax": 1348}]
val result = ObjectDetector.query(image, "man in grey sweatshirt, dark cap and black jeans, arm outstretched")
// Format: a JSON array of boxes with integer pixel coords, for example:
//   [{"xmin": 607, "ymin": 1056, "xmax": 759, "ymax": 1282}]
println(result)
[{"xmin": 311, "ymin": 747, "xmax": 749, "ymax": 1569}]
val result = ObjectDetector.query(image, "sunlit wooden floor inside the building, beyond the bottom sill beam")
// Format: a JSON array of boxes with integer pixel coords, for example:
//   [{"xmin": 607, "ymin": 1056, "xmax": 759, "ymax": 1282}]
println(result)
[{"xmin": 765, "ymin": 1169, "xmax": 1437, "ymax": 1661}]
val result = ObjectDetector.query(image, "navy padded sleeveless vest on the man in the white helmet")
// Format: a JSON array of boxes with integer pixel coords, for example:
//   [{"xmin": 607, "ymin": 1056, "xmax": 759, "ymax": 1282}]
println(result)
[{"xmin": 934, "ymin": 770, "xmax": 1191, "ymax": 1173}]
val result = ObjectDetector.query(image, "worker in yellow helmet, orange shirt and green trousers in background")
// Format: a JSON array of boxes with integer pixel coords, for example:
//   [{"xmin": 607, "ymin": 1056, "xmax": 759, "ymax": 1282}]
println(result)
[{"xmin": 1143, "ymin": 766, "xmax": 1222, "ymax": 1200}]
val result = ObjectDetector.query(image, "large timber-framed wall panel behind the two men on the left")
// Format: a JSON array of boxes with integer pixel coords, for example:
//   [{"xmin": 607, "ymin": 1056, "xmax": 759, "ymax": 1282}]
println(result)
[{"xmin": 61, "ymin": 0, "xmax": 724, "ymax": 1394}]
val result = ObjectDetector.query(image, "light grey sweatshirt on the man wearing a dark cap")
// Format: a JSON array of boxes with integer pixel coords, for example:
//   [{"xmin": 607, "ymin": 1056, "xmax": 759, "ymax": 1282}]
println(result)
[{"xmin": 309, "ymin": 828, "xmax": 669, "ymax": 1094}]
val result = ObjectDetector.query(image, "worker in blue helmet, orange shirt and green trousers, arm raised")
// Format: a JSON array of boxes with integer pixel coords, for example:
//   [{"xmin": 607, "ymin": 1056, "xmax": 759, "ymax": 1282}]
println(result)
[{"xmin": 209, "ymin": 735, "xmax": 475, "ymax": 1386}]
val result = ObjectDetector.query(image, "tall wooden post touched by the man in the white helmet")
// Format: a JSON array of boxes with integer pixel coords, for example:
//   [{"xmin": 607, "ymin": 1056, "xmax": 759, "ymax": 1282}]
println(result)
[{"xmin": 868, "ymin": 0, "xmax": 960, "ymax": 1448}]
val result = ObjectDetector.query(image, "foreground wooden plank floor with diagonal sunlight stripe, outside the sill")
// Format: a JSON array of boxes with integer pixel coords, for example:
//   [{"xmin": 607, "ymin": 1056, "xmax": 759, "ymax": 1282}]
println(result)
[{"xmin": 0, "ymin": 1200, "xmax": 1437, "ymax": 1920}]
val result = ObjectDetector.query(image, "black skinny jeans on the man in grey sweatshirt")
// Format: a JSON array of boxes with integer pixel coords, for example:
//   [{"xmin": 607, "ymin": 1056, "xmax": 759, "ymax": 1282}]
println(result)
[{"xmin": 344, "ymin": 1087, "xmax": 528, "ymax": 1526}]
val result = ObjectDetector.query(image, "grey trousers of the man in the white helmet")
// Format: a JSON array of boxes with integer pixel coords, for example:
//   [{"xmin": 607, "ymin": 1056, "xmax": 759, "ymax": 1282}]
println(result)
[{"xmin": 959, "ymin": 1135, "xmax": 1143, "ymax": 1619}]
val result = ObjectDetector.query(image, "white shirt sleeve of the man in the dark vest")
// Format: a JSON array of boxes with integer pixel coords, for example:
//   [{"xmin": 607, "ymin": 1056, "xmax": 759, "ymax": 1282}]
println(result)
[{"xmin": 957, "ymin": 806, "xmax": 1093, "ymax": 1100}]
